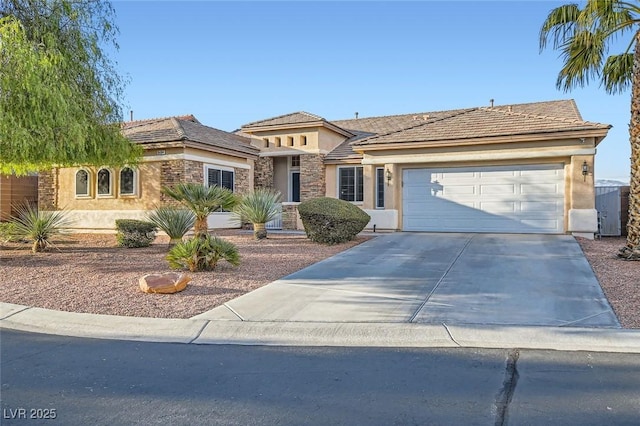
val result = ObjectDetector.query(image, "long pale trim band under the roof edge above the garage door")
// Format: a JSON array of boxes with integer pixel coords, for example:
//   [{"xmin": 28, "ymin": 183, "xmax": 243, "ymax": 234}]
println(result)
[{"xmin": 362, "ymin": 148, "xmax": 596, "ymax": 165}]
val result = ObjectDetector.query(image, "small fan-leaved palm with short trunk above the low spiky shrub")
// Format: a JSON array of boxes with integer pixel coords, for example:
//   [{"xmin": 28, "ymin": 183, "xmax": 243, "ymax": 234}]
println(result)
[{"xmin": 162, "ymin": 183, "xmax": 238, "ymax": 237}]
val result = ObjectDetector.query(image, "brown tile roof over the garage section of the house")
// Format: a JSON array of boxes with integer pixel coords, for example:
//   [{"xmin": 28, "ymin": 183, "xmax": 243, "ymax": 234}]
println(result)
[{"xmin": 325, "ymin": 100, "xmax": 610, "ymax": 161}]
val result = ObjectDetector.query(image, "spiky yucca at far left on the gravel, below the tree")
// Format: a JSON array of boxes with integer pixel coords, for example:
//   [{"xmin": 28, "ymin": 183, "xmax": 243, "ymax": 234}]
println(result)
[{"xmin": 11, "ymin": 202, "xmax": 71, "ymax": 253}]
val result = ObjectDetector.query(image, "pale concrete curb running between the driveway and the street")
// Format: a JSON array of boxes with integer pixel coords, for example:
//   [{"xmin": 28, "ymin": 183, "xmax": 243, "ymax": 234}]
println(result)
[{"xmin": 0, "ymin": 303, "xmax": 640, "ymax": 353}]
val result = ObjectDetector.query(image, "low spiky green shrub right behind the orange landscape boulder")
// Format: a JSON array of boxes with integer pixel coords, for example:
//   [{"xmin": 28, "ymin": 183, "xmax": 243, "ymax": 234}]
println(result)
[{"xmin": 166, "ymin": 235, "xmax": 240, "ymax": 272}]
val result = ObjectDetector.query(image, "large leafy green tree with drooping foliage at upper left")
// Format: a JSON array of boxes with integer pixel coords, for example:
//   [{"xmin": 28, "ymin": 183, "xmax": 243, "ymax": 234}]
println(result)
[{"xmin": 0, "ymin": 0, "xmax": 142, "ymax": 174}]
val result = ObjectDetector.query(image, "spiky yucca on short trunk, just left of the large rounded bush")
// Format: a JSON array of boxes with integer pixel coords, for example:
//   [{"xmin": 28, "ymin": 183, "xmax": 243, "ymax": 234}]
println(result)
[{"xmin": 233, "ymin": 188, "xmax": 280, "ymax": 240}]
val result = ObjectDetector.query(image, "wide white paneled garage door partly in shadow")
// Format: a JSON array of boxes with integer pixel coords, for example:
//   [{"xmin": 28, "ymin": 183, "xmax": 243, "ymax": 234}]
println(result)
[{"xmin": 402, "ymin": 164, "xmax": 564, "ymax": 234}]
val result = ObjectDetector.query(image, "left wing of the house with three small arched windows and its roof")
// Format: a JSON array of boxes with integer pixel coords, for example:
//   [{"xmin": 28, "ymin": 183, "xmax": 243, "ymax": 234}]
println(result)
[{"xmin": 38, "ymin": 115, "xmax": 260, "ymax": 230}]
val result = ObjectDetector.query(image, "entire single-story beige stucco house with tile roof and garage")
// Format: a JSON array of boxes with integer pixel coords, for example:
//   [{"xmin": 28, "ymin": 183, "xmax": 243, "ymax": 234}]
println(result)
[{"xmin": 40, "ymin": 100, "xmax": 610, "ymax": 237}]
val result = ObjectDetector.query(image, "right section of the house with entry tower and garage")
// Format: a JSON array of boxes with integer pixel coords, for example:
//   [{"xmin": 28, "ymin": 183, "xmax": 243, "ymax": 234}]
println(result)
[{"xmin": 241, "ymin": 100, "xmax": 611, "ymax": 237}]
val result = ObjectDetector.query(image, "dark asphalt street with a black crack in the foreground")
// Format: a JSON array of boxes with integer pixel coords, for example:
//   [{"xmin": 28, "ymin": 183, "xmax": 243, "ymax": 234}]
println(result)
[{"xmin": 0, "ymin": 330, "xmax": 640, "ymax": 425}]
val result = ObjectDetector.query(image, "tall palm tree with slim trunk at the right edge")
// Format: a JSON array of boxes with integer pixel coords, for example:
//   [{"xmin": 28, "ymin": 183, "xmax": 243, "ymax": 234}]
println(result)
[{"xmin": 540, "ymin": 0, "xmax": 640, "ymax": 260}]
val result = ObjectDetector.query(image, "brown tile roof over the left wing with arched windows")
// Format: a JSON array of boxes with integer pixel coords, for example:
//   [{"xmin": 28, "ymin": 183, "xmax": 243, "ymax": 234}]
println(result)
[{"xmin": 122, "ymin": 115, "xmax": 259, "ymax": 155}]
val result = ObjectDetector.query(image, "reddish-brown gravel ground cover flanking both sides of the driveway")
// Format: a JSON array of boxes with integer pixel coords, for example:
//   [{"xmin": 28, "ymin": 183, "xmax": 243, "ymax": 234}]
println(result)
[{"xmin": 0, "ymin": 230, "xmax": 640, "ymax": 328}]
